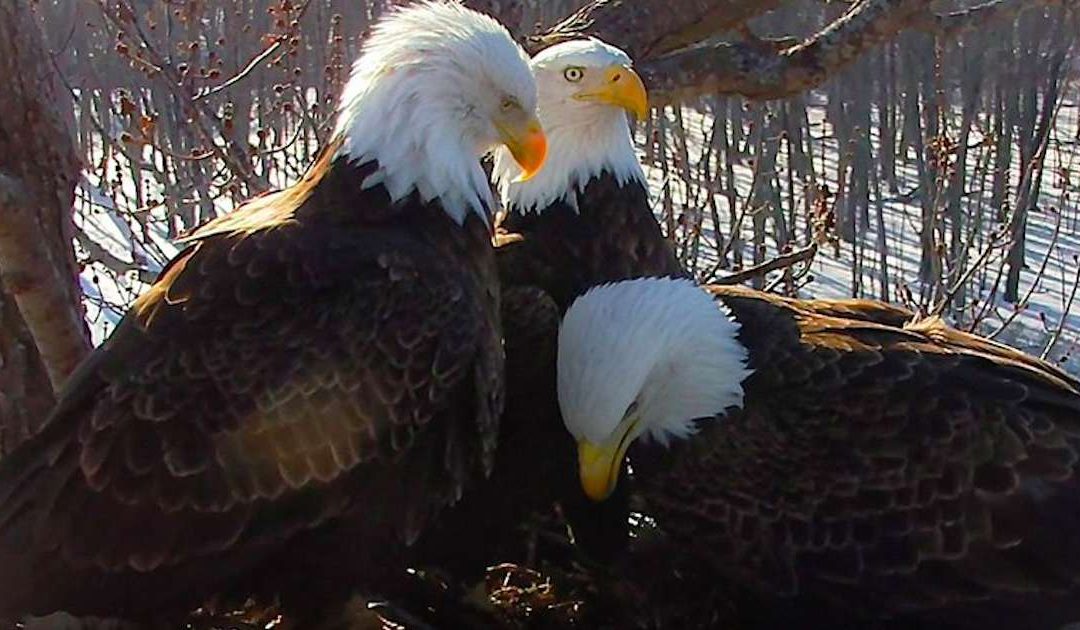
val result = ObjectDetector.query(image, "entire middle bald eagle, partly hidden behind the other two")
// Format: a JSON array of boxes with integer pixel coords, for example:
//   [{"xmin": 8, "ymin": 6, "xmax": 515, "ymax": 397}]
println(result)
[{"xmin": 408, "ymin": 39, "xmax": 681, "ymax": 575}]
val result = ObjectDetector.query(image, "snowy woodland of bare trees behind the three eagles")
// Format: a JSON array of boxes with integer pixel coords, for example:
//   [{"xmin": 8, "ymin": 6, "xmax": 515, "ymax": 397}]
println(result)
[{"xmin": 0, "ymin": 0, "xmax": 1080, "ymax": 626}]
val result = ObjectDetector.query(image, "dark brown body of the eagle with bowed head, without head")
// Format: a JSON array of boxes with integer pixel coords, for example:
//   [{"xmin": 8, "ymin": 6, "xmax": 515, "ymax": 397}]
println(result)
[{"xmin": 631, "ymin": 287, "xmax": 1080, "ymax": 629}]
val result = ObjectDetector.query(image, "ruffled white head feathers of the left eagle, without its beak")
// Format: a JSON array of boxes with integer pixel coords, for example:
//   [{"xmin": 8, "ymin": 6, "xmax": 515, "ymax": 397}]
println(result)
[{"xmin": 336, "ymin": 1, "xmax": 537, "ymax": 224}]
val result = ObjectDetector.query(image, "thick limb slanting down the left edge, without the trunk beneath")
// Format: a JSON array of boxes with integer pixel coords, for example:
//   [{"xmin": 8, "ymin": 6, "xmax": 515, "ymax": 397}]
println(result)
[{"xmin": 0, "ymin": 0, "xmax": 90, "ymax": 388}]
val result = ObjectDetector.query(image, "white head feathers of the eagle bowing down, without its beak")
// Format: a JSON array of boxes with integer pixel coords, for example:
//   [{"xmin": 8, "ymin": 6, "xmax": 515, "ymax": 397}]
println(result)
[{"xmin": 557, "ymin": 278, "xmax": 751, "ymax": 444}]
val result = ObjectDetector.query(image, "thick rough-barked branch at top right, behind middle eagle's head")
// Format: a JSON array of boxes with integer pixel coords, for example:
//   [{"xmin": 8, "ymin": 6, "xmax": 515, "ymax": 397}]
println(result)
[{"xmin": 540, "ymin": 0, "xmax": 1075, "ymax": 105}]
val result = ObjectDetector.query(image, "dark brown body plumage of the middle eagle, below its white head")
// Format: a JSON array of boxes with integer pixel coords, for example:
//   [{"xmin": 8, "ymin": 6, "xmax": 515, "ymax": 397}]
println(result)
[{"xmin": 412, "ymin": 173, "xmax": 683, "ymax": 571}]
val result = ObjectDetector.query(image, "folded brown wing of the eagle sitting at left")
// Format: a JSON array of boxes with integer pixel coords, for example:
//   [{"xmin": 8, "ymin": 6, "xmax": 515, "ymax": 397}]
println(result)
[{"xmin": 0, "ymin": 159, "xmax": 501, "ymax": 609}]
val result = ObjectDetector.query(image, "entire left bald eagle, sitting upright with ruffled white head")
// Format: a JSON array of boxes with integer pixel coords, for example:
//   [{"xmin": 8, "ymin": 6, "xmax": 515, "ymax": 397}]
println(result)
[{"xmin": 0, "ymin": 2, "xmax": 545, "ymax": 619}]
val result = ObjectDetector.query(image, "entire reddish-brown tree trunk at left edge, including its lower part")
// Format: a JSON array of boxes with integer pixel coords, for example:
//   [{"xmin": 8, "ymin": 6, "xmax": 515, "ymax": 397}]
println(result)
[{"xmin": 0, "ymin": 0, "xmax": 90, "ymax": 451}]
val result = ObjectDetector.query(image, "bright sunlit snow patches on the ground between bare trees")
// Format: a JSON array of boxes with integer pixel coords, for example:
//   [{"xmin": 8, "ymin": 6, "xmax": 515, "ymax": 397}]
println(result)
[{"xmin": 76, "ymin": 91, "xmax": 1080, "ymax": 374}]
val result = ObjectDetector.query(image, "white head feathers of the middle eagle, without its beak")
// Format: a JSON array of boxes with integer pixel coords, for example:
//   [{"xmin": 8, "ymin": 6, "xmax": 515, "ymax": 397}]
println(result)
[{"xmin": 492, "ymin": 38, "xmax": 645, "ymax": 213}]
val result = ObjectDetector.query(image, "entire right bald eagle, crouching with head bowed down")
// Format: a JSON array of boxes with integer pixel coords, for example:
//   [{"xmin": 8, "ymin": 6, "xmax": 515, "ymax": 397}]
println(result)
[{"xmin": 557, "ymin": 278, "xmax": 1080, "ymax": 628}]
